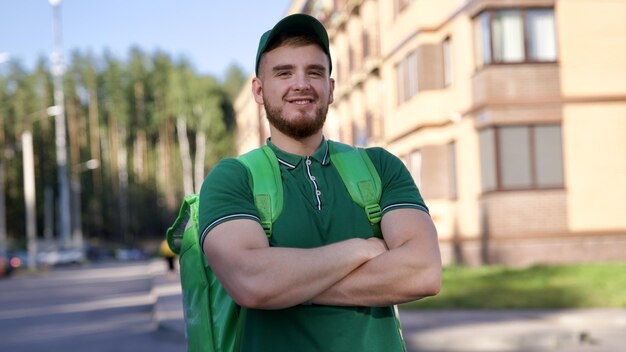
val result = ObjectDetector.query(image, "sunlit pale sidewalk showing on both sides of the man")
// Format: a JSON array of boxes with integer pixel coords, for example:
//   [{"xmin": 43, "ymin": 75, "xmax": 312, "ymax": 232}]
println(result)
[{"xmin": 150, "ymin": 261, "xmax": 626, "ymax": 352}]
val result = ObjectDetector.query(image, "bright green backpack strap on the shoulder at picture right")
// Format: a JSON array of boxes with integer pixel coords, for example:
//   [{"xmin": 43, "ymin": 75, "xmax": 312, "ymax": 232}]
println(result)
[{"xmin": 328, "ymin": 141, "xmax": 382, "ymax": 225}]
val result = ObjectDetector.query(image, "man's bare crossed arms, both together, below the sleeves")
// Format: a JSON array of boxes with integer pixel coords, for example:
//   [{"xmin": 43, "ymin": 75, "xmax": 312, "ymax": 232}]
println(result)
[{"xmin": 203, "ymin": 208, "xmax": 441, "ymax": 309}]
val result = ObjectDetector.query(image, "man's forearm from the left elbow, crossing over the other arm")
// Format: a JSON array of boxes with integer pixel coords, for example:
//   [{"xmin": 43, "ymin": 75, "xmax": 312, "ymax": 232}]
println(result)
[{"xmin": 207, "ymin": 234, "xmax": 384, "ymax": 309}]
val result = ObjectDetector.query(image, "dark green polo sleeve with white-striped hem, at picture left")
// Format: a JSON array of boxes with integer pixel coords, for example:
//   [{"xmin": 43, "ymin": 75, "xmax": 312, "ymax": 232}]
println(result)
[{"xmin": 198, "ymin": 158, "xmax": 260, "ymax": 247}]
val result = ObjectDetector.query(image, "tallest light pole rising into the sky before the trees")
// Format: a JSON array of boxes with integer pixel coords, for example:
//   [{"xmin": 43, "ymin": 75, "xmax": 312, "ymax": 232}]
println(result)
[{"xmin": 48, "ymin": 0, "xmax": 71, "ymax": 246}]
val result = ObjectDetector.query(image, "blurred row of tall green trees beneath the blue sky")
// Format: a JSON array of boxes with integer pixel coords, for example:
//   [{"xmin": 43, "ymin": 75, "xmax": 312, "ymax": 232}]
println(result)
[{"xmin": 0, "ymin": 47, "xmax": 246, "ymax": 247}]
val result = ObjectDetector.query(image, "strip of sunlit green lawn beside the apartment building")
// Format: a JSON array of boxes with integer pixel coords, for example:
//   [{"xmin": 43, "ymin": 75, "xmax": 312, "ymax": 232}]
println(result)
[{"xmin": 401, "ymin": 262, "xmax": 626, "ymax": 309}]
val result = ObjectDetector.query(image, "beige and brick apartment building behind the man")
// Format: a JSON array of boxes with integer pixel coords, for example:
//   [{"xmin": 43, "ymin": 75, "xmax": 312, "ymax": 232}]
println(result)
[{"xmin": 235, "ymin": 0, "xmax": 626, "ymax": 265}]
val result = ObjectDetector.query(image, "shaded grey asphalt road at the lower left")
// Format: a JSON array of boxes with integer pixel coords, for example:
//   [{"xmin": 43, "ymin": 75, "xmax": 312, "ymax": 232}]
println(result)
[{"xmin": 0, "ymin": 263, "xmax": 185, "ymax": 352}]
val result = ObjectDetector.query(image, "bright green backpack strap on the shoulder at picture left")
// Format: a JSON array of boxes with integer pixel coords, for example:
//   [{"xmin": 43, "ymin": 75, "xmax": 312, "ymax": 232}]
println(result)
[{"xmin": 238, "ymin": 145, "xmax": 283, "ymax": 237}]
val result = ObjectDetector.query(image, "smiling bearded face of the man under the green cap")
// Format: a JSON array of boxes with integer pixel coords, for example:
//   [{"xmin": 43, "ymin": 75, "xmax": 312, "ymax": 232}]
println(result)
[{"xmin": 253, "ymin": 38, "xmax": 334, "ymax": 140}]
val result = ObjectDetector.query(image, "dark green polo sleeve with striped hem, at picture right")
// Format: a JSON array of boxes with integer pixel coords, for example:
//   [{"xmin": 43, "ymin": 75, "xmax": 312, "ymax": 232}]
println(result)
[{"xmin": 366, "ymin": 148, "xmax": 428, "ymax": 215}]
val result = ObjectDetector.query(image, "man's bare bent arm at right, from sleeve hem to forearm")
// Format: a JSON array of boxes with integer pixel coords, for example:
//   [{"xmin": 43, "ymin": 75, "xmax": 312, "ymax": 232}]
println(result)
[{"xmin": 312, "ymin": 209, "xmax": 441, "ymax": 306}]
